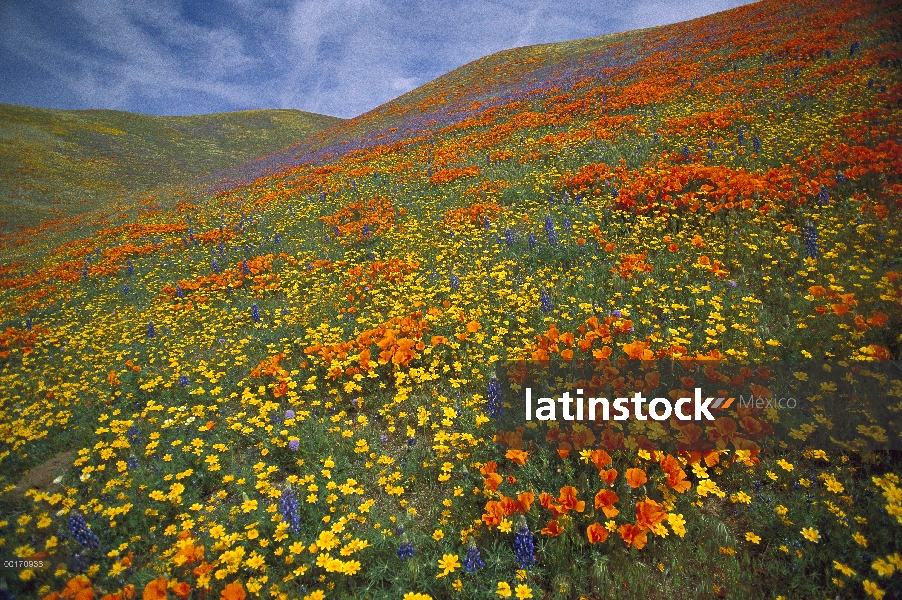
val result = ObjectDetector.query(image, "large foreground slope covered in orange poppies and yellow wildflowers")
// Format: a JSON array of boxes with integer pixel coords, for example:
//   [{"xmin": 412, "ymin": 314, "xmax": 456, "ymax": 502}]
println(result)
[{"xmin": 0, "ymin": 0, "xmax": 902, "ymax": 600}]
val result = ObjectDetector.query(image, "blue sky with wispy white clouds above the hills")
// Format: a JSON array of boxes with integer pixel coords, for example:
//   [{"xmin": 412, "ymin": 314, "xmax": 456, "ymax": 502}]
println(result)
[{"xmin": 0, "ymin": 0, "xmax": 747, "ymax": 117}]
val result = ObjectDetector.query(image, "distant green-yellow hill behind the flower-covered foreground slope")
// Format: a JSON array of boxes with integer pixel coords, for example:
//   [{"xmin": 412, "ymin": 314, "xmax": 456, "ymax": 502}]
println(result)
[{"xmin": 0, "ymin": 104, "xmax": 342, "ymax": 231}]
